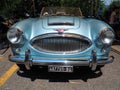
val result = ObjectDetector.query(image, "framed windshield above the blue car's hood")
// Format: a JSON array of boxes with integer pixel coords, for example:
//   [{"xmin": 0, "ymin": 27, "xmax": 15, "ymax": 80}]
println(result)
[{"xmin": 40, "ymin": 7, "xmax": 82, "ymax": 17}]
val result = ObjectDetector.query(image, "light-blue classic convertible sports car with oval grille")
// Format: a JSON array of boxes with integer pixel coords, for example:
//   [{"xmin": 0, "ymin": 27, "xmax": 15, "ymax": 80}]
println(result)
[{"xmin": 7, "ymin": 7, "xmax": 114, "ymax": 72}]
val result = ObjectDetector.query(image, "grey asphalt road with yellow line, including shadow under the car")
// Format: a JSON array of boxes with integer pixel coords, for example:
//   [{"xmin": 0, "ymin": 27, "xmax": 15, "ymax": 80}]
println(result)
[{"xmin": 0, "ymin": 47, "xmax": 120, "ymax": 90}]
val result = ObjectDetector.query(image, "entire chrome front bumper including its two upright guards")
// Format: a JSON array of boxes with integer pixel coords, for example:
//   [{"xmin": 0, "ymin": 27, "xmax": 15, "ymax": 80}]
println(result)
[{"xmin": 9, "ymin": 50, "xmax": 114, "ymax": 70}]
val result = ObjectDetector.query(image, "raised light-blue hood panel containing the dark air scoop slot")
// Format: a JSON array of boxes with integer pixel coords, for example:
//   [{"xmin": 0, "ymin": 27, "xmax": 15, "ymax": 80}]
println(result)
[{"xmin": 43, "ymin": 16, "xmax": 80, "ymax": 29}]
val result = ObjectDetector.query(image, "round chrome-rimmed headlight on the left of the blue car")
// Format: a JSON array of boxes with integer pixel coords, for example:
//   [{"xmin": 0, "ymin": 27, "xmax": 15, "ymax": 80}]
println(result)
[{"xmin": 7, "ymin": 28, "xmax": 23, "ymax": 44}]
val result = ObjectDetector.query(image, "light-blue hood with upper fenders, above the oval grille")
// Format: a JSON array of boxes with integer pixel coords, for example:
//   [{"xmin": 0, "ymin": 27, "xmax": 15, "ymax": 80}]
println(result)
[{"xmin": 13, "ymin": 16, "xmax": 108, "ymax": 39}]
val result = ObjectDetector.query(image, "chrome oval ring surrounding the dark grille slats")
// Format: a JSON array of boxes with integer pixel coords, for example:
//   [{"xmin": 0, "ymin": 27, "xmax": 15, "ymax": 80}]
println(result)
[{"xmin": 30, "ymin": 33, "xmax": 92, "ymax": 54}]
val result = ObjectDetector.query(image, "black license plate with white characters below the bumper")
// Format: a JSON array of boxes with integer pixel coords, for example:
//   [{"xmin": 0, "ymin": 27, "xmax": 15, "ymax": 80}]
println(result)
[{"xmin": 48, "ymin": 65, "xmax": 73, "ymax": 72}]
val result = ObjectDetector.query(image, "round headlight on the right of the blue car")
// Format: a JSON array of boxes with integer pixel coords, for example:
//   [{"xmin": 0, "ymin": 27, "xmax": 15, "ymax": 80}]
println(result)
[{"xmin": 100, "ymin": 29, "xmax": 115, "ymax": 44}]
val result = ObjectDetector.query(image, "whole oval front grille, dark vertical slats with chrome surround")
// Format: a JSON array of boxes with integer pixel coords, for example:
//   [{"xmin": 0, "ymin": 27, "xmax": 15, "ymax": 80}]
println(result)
[{"xmin": 31, "ymin": 34, "xmax": 91, "ymax": 53}]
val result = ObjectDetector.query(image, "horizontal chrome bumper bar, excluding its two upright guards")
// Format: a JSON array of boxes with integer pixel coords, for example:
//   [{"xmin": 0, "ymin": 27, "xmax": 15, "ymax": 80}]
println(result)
[{"xmin": 9, "ymin": 57, "xmax": 114, "ymax": 66}]
